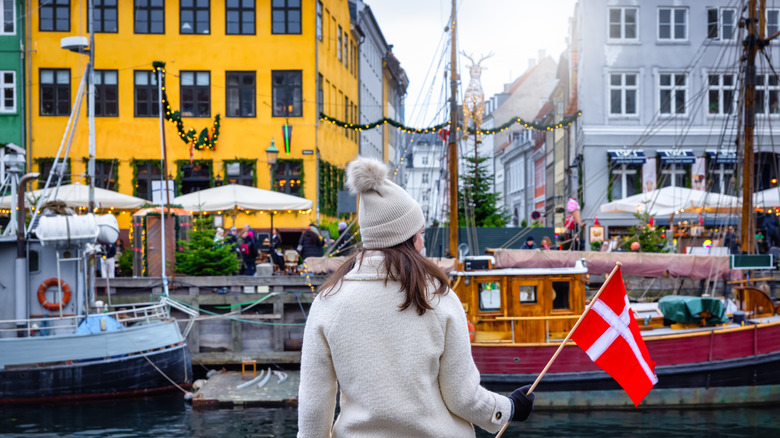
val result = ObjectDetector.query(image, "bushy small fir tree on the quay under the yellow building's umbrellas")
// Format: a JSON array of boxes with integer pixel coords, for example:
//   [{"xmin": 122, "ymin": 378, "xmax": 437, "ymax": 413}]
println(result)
[{"xmin": 176, "ymin": 217, "xmax": 238, "ymax": 276}]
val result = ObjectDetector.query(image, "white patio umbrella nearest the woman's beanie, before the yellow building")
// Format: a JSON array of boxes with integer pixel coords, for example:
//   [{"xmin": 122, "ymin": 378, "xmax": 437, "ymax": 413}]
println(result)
[{"xmin": 173, "ymin": 184, "xmax": 314, "ymax": 213}]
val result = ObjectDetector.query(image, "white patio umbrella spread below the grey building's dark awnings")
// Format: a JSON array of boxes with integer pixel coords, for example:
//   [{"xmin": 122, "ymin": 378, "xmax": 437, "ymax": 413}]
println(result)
[{"xmin": 601, "ymin": 187, "xmax": 742, "ymax": 216}]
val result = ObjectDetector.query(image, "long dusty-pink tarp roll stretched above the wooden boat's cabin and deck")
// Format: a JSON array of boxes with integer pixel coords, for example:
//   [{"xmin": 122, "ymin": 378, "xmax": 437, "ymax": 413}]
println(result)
[{"xmin": 493, "ymin": 249, "xmax": 740, "ymax": 280}]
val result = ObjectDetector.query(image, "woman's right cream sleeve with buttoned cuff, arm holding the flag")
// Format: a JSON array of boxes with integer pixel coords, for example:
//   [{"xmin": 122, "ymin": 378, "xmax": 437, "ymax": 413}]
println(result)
[{"xmin": 439, "ymin": 291, "xmax": 512, "ymax": 433}]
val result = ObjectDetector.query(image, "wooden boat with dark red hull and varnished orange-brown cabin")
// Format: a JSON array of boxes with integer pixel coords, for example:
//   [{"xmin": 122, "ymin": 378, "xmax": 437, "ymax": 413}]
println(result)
[{"xmin": 450, "ymin": 257, "xmax": 780, "ymax": 409}]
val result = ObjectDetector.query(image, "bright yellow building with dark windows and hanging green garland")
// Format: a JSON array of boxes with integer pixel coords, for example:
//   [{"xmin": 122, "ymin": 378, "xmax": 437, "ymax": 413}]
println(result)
[{"xmin": 28, "ymin": 0, "xmax": 358, "ymax": 234}]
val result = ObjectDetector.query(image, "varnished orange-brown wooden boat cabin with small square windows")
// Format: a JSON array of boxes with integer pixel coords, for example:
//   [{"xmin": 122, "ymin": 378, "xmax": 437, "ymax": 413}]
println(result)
[{"xmin": 450, "ymin": 256, "xmax": 588, "ymax": 344}]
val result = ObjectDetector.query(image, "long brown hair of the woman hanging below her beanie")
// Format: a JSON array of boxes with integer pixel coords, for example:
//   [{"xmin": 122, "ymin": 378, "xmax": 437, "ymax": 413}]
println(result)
[{"xmin": 319, "ymin": 236, "xmax": 449, "ymax": 315}]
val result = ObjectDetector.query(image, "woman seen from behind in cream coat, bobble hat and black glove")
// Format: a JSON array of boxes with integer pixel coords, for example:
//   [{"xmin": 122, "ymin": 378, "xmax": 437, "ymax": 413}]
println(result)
[{"xmin": 298, "ymin": 158, "xmax": 534, "ymax": 438}]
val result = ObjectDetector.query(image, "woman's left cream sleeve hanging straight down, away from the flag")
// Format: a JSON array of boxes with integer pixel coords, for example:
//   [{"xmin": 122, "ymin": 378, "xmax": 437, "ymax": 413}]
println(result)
[{"xmin": 298, "ymin": 299, "xmax": 338, "ymax": 438}]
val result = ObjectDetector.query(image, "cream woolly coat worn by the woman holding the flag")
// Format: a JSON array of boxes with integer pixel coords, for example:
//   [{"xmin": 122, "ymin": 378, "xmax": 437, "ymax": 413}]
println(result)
[{"xmin": 298, "ymin": 252, "xmax": 512, "ymax": 438}]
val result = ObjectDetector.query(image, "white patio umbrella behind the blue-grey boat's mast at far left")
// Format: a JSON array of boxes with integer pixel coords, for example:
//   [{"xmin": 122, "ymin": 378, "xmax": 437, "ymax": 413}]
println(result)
[{"xmin": 0, "ymin": 183, "xmax": 149, "ymax": 210}]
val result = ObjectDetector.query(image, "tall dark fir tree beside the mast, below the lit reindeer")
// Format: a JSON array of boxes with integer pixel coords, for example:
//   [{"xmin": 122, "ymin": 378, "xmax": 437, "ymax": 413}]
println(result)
[{"xmin": 458, "ymin": 157, "xmax": 510, "ymax": 227}]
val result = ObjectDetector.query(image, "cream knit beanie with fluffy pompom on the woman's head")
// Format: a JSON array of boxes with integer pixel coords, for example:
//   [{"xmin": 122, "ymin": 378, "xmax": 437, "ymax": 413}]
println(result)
[{"xmin": 346, "ymin": 158, "xmax": 425, "ymax": 249}]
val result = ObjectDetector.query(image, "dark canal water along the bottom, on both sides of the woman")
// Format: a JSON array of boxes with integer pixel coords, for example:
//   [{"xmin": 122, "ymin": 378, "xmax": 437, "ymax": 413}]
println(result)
[{"xmin": 0, "ymin": 396, "xmax": 780, "ymax": 438}]
